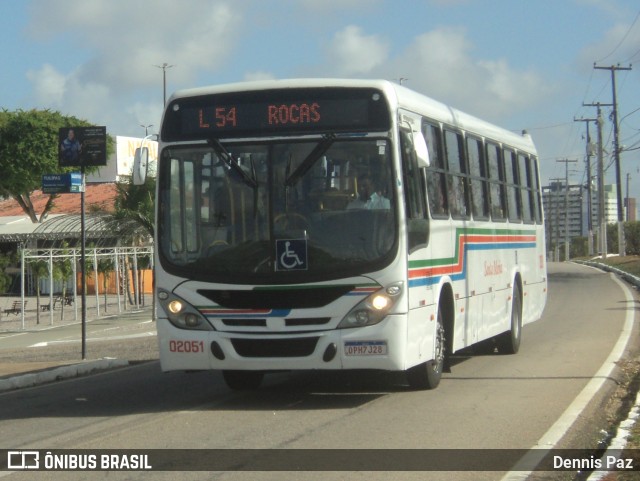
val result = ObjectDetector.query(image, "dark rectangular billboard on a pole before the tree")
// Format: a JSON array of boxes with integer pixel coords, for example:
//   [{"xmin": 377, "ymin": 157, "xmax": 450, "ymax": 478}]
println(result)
[{"xmin": 58, "ymin": 127, "xmax": 107, "ymax": 167}]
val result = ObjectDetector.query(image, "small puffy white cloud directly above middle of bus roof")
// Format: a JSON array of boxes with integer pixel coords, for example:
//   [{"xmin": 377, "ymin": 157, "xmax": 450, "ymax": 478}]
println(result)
[{"xmin": 328, "ymin": 25, "xmax": 389, "ymax": 76}]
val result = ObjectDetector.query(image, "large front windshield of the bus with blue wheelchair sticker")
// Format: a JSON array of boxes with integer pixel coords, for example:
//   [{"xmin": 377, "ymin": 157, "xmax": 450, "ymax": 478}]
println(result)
[{"xmin": 158, "ymin": 135, "xmax": 398, "ymax": 284}]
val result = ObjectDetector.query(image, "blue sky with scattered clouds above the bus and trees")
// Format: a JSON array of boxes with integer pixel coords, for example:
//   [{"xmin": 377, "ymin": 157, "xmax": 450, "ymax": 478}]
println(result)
[{"xmin": 0, "ymin": 0, "xmax": 640, "ymax": 198}]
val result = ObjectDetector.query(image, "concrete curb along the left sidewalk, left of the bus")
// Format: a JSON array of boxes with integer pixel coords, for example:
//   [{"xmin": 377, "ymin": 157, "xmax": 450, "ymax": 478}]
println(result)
[{"xmin": 0, "ymin": 358, "xmax": 129, "ymax": 393}]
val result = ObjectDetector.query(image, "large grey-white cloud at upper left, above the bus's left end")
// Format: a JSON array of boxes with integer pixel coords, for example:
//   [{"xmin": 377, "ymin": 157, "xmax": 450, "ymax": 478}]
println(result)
[{"xmin": 30, "ymin": 0, "xmax": 240, "ymax": 89}]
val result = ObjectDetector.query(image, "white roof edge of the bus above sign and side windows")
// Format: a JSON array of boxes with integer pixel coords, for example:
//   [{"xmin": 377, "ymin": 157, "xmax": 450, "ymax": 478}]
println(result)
[{"xmin": 167, "ymin": 78, "xmax": 536, "ymax": 154}]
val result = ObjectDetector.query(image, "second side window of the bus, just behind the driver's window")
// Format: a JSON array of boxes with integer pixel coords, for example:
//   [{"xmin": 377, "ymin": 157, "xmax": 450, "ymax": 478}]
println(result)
[{"xmin": 422, "ymin": 123, "xmax": 449, "ymax": 219}]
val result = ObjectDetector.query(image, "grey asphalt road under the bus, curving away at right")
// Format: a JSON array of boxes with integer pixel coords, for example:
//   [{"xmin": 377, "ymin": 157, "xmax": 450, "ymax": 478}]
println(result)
[{"xmin": 0, "ymin": 264, "xmax": 637, "ymax": 481}]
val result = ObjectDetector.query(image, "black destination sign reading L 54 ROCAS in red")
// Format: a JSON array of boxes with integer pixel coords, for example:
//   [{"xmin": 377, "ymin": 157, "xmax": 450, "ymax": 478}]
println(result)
[{"xmin": 162, "ymin": 88, "xmax": 391, "ymax": 141}]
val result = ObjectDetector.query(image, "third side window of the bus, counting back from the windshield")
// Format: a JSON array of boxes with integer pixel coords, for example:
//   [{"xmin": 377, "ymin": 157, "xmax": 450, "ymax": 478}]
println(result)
[{"xmin": 444, "ymin": 129, "xmax": 469, "ymax": 219}]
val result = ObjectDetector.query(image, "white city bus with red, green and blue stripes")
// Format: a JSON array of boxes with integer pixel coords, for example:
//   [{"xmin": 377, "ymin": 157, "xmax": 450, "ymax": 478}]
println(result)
[{"xmin": 149, "ymin": 79, "xmax": 547, "ymax": 389}]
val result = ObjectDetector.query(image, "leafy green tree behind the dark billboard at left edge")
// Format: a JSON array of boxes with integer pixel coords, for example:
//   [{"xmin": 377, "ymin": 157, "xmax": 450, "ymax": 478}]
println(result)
[{"xmin": 0, "ymin": 110, "xmax": 113, "ymax": 223}]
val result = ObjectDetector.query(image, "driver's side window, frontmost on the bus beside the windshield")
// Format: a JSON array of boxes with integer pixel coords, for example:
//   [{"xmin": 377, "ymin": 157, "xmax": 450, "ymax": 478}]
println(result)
[{"xmin": 400, "ymin": 130, "xmax": 429, "ymax": 252}]
